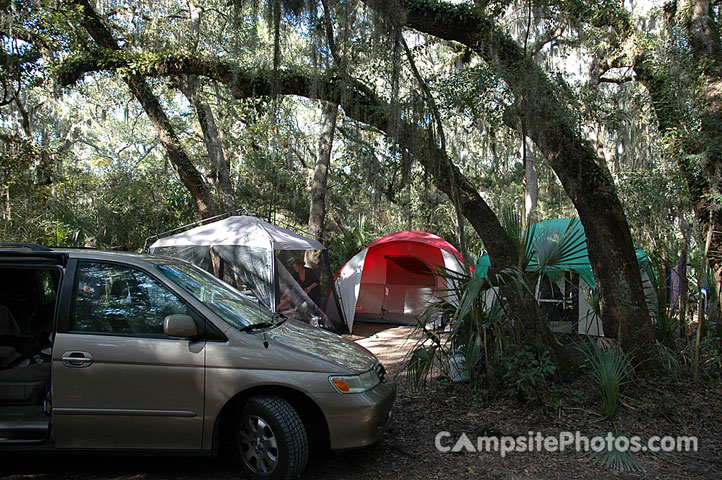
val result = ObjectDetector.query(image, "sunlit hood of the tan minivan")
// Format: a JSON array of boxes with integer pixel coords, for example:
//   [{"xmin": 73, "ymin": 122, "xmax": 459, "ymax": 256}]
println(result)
[{"xmin": 267, "ymin": 320, "xmax": 378, "ymax": 373}]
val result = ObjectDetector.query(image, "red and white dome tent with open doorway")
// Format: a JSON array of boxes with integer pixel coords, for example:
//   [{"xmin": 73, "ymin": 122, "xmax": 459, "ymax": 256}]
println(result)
[{"xmin": 336, "ymin": 230, "xmax": 464, "ymax": 331}]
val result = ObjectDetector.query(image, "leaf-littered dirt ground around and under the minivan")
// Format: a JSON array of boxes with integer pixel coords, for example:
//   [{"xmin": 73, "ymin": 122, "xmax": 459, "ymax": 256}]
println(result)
[{"xmin": 0, "ymin": 326, "xmax": 722, "ymax": 480}]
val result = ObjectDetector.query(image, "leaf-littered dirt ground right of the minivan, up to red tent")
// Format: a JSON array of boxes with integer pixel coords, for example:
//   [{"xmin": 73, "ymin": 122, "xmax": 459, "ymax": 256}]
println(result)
[{"xmin": 330, "ymin": 326, "xmax": 722, "ymax": 479}]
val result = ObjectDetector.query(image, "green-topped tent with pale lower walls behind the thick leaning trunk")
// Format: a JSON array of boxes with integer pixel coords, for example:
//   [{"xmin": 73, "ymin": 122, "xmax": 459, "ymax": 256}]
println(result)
[{"xmin": 474, "ymin": 218, "xmax": 657, "ymax": 335}]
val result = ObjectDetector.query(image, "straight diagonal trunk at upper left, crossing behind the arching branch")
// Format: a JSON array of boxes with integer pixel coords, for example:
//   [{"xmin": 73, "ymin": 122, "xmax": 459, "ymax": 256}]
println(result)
[{"xmin": 70, "ymin": 0, "xmax": 217, "ymax": 218}]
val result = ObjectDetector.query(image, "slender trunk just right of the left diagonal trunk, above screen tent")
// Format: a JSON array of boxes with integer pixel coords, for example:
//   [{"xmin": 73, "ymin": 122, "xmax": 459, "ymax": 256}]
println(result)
[{"xmin": 178, "ymin": 78, "xmax": 238, "ymax": 212}]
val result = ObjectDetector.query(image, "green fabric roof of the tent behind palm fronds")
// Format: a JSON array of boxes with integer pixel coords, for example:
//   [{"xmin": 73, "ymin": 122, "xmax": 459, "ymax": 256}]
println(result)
[{"xmin": 474, "ymin": 218, "xmax": 651, "ymax": 288}]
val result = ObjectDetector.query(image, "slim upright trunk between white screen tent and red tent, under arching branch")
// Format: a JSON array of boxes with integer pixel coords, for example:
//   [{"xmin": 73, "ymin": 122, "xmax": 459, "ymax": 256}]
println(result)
[{"xmin": 308, "ymin": 102, "xmax": 338, "ymax": 242}]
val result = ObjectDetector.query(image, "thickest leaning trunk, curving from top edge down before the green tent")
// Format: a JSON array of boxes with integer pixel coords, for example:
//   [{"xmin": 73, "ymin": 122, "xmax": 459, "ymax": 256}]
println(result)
[{"xmin": 362, "ymin": 0, "xmax": 654, "ymax": 359}]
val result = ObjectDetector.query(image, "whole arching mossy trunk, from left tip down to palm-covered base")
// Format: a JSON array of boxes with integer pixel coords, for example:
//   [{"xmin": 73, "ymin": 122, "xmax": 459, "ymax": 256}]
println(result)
[{"xmin": 59, "ymin": 52, "xmax": 570, "ymax": 372}]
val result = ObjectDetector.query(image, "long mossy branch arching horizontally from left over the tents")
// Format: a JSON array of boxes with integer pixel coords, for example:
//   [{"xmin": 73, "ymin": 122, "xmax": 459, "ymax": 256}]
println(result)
[{"xmin": 57, "ymin": 50, "xmax": 515, "ymax": 265}]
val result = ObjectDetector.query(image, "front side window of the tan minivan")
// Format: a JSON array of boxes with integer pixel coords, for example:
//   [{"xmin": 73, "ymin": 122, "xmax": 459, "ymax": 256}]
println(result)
[{"xmin": 70, "ymin": 262, "xmax": 190, "ymax": 337}]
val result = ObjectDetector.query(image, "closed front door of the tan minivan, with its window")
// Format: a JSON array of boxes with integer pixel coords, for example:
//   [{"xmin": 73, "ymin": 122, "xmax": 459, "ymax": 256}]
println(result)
[{"xmin": 52, "ymin": 261, "xmax": 206, "ymax": 450}]
